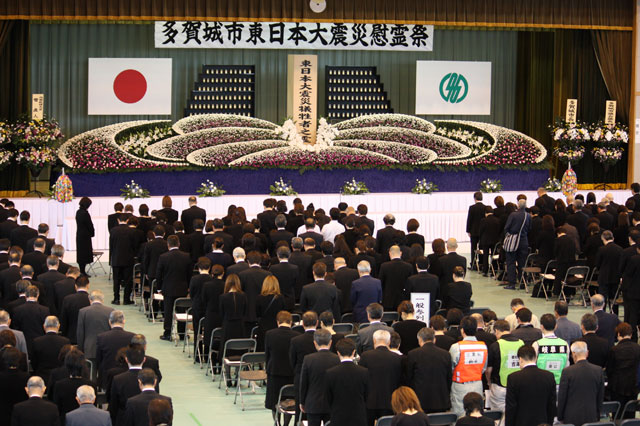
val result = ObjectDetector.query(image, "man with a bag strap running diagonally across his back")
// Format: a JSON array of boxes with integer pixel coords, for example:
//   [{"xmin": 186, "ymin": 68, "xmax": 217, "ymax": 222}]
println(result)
[{"xmin": 504, "ymin": 198, "xmax": 531, "ymax": 290}]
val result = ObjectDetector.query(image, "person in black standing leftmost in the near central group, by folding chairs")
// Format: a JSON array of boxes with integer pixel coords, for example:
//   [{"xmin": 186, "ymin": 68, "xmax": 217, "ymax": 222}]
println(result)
[{"xmin": 264, "ymin": 311, "xmax": 300, "ymax": 414}]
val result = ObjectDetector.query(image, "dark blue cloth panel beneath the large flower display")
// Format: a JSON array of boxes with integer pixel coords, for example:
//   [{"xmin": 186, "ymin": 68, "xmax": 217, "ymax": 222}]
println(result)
[{"xmin": 63, "ymin": 169, "xmax": 549, "ymax": 197}]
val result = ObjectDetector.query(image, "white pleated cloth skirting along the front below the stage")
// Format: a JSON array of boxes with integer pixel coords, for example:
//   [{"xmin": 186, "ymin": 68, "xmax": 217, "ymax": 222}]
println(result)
[{"xmin": 13, "ymin": 190, "xmax": 631, "ymax": 251}]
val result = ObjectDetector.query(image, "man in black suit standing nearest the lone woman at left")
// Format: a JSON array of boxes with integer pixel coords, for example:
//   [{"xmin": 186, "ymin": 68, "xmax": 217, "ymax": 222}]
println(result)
[{"xmin": 109, "ymin": 213, "xmax": 136, "ymax": 305}]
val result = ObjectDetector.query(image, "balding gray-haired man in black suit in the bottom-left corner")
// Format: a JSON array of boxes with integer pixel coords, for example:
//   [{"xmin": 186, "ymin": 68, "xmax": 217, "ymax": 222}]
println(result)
[{"xmin": 11, "ymin": 376, "xmax": 60, "ymax": 426}]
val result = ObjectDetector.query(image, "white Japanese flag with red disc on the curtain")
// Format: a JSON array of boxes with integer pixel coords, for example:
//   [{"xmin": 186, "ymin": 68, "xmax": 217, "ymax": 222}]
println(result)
[{"xmin": 88, "ymin": 58, "xmax": 171, "ymax": 115}]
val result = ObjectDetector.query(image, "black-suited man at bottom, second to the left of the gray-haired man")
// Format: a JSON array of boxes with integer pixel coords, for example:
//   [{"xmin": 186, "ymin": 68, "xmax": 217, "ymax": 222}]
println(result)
[{"xmin": 300, "ymin": 330, "xmax": 340, "ymax": 426}]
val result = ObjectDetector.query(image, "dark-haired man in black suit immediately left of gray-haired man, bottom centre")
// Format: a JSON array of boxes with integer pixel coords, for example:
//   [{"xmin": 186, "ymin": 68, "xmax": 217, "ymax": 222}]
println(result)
[{"xmin": 325, "ymin": 339, "xmax": 368, "ymax": 426}]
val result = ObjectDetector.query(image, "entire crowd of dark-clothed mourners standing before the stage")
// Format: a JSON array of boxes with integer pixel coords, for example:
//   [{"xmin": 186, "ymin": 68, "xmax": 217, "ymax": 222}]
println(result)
[{"xmin": 0, "ymin": 184, "xmax": 640, "ymax": 426}]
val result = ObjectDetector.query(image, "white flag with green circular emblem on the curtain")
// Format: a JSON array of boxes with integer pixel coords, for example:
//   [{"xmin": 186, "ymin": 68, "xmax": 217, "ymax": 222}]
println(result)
[{"xmin": 416, "ymin": 61, "xmax": 491, "ymax": 115}]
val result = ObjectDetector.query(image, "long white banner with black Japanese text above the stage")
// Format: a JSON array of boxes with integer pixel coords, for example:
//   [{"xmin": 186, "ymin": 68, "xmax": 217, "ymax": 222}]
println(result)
[{"xmin": 154, "ymin": 21, "xmax": 433, "ymax": 52}]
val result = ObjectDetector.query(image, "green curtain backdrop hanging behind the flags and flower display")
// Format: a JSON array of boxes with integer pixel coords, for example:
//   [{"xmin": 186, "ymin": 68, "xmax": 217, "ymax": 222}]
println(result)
[{"xmin": 31, "ymin": 23, "xmax": 518, "ymax": 136}]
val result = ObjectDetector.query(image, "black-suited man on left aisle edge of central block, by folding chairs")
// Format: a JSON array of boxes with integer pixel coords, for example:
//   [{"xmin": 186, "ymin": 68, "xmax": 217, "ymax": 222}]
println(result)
[{"xmin": 156, "ymin": 235, "xmax": 193, "ymax": 340}]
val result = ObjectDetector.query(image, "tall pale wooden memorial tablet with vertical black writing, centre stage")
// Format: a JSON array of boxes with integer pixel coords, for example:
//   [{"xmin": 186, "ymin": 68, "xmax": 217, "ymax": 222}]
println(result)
[{"xmin": 287, "ymin": 55, "xmax": 318, "ymax": 144}]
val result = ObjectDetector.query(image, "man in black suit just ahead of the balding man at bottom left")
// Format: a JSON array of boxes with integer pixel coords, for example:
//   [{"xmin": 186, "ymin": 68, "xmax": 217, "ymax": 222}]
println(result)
[{"xmin": 31, "ymin": 316, "xmax": 71, "ymax": 386}]
